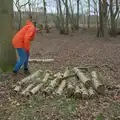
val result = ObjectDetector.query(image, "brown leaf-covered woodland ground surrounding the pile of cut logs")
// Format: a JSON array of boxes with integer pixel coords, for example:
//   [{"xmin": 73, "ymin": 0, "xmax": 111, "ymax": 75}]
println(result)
[{"xmin": 0, "ymin": 30, "xmax": 120, "ymax": 120}]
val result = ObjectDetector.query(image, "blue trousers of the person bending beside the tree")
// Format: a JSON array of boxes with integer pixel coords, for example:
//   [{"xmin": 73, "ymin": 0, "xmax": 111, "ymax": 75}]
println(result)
[{"xmin": 13, "ymin": 48, "xmax": 29, "ymax": 73}]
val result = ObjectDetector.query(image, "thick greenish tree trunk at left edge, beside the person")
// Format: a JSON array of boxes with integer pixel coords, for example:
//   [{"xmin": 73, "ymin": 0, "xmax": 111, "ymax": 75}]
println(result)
[{"xmin": 0, "ymin": 0, "xmax": 16, "ymax": 71}]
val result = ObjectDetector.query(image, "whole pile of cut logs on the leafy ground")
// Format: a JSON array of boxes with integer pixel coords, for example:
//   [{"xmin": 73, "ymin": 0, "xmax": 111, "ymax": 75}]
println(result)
[{"xmin": 14, "ymin": 67, "xmax": 105, "ymax": 100}]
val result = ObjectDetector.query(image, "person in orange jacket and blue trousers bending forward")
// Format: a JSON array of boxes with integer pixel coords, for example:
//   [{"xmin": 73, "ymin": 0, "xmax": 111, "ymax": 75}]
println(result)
[{"xmin": 12, "ymin": 17, "xmax": 36, "ymax": 75}]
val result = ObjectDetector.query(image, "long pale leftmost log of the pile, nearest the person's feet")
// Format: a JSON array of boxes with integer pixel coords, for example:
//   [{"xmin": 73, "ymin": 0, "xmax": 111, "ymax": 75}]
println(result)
[{"xmin": 14, "ymin": 70, "xmax": 41, "ymax": 92}]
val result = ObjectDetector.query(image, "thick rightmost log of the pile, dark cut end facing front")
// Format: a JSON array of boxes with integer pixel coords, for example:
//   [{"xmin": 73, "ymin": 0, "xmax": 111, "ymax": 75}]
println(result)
[{"xmin": 91, "ymin": 71, "xmax": 105, "ymax": 95}]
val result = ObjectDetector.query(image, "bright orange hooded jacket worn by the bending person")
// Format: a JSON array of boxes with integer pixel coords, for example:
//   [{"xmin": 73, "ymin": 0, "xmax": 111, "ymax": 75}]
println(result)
[{"xmin": 12, "ymin": 21, "xmax": 36, "ymax": 51}]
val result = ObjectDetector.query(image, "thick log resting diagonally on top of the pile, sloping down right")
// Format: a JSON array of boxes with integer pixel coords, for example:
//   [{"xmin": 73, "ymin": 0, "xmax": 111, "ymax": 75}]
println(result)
[{"xmin": 73, "ymin": 67, "xmax": 91, "ymax": 88}]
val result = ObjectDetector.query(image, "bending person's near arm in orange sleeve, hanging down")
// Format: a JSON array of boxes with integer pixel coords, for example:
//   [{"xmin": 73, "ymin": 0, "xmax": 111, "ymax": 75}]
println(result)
[{"xmin": 24, "ymin": 27, "xmax": 36, "ymax": 52}]
